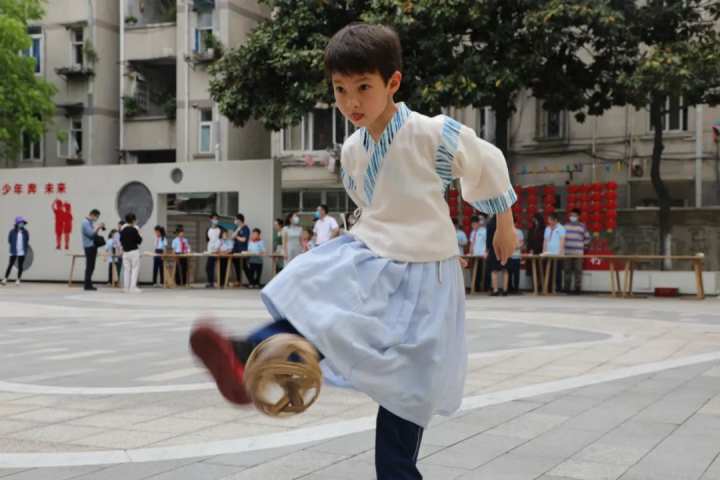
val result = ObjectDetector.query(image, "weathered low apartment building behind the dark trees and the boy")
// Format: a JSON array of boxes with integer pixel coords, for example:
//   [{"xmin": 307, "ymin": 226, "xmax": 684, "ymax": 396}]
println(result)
[{"xmin": 272, "ymin": 97, "xmax": 720, "ymax": 212}]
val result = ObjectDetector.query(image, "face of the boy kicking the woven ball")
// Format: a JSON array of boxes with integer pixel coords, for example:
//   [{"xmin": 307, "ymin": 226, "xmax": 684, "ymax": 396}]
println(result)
[{"xmin": 332, "ymin": 72, "xmax": 402, "ymax": 128}]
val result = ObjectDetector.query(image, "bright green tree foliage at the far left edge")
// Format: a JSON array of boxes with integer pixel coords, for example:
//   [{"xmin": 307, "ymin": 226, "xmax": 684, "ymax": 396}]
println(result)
[{"xmin": 0, "ymin": 0, "xmax": 55, "ymax": 164}]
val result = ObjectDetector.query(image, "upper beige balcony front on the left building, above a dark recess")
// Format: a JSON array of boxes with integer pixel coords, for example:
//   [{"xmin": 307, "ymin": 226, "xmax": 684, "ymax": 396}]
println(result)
[{"xmin": 125, "ymin": 23, "xmax": 177, "ymax": 63}]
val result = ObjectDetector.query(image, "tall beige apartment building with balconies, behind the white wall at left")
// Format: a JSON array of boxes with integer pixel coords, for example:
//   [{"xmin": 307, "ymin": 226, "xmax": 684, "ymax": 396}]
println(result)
[{"xmin": 12, "ymin": 0, "xmax": 270, "ymax": 171}]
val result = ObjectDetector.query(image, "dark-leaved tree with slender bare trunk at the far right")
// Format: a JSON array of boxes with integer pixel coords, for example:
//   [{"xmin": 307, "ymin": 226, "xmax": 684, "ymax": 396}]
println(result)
[{"xmin": 619, "ymin": 0, "xmax": 720, "ymax": 255}]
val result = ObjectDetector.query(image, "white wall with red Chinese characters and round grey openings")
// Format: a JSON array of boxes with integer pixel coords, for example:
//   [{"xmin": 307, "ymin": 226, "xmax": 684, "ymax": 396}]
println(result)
[{"xmin": 0, "ymin": 160, "xmax": 280, "ymax": 282}]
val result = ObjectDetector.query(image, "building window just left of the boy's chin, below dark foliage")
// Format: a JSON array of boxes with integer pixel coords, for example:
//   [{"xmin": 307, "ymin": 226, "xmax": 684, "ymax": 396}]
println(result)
[{"xmin": 282, "ymin": 107, "xmax": 355, "ymax": 152}]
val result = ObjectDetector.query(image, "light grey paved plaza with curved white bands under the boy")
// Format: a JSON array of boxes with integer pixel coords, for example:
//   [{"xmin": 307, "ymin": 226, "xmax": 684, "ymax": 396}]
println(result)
[{"xmin": 0, "ymin": 284, "xmax": 720, "ymax": 480}]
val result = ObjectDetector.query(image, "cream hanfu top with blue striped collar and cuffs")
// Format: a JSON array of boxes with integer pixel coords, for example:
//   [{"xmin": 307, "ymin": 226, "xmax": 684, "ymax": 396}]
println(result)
[{"xmin": 341, "ymin": 103, "xmax": 517, "ymax": 262}]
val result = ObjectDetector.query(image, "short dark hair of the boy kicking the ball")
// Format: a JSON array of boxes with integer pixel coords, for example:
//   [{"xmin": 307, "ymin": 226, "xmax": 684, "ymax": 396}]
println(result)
[{"xmin": 325, "ymin": 23, "xmax": 402, "ymax": 83}]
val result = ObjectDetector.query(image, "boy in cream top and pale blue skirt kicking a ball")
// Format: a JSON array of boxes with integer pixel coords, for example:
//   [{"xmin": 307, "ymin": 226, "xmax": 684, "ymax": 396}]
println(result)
[{"xmin": 190, "ymin": 24, "xmax": 516, "ymax": 480}]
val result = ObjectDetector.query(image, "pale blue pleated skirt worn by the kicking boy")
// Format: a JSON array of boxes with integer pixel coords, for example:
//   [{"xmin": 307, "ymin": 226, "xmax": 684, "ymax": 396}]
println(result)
[{"xmin": 262, "ymin": 234, "xmax": 467, "ymax": 427}]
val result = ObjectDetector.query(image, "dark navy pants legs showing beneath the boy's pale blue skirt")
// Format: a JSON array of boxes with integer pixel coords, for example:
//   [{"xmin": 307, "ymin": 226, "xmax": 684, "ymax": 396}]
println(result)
[{"xmin": 247, "ymin": 320, "xmax": 423, "ymax": 480}]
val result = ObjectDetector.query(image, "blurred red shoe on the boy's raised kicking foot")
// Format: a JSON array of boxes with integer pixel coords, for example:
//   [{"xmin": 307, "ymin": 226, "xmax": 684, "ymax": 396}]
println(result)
[{"xmin": 190, "ymin": 323, "xmax": 251, "ymax": 405}]
